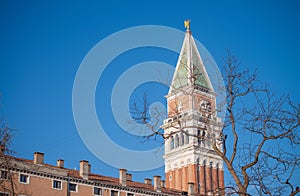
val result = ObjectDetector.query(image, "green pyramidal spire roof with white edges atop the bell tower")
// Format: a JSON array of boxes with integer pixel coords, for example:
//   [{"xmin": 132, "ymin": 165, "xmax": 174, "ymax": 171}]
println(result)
[{"xmin": 169, "ymin": 30, "xmax": 214, "ymax": 94}]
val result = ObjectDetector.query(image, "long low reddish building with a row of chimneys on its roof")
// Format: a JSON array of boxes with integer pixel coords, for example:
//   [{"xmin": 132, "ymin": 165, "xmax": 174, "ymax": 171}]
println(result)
[{"xmin": 0, "ymin": 152, "xmax": 182, "ymax": 196}]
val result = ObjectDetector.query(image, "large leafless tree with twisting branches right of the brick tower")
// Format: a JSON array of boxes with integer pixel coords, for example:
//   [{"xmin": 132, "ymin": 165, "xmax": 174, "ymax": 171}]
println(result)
[{"xmin": 131, "ymin": 53, "xmax": 300, "ymax": 195}]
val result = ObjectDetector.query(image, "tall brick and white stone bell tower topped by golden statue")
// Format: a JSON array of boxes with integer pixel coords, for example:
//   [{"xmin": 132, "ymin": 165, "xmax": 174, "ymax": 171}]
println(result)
[{"xmin": 162, "ymin": 20, "xmax": 224, "ymax": 195}]
